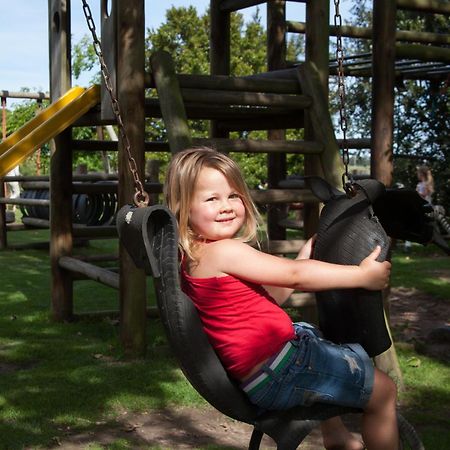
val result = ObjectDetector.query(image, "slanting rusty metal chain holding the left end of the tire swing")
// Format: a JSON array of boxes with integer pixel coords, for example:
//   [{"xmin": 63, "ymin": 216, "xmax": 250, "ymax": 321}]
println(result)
[{"xmin": 82, "ymin": 0, "xmax": 149, "ymax": 207}]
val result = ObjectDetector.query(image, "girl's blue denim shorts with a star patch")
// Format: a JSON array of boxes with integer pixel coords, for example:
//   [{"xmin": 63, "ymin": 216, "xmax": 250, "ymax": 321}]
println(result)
[{"xmin": 241, "ymin": 322, "xmax": 374, "ymax": 410}]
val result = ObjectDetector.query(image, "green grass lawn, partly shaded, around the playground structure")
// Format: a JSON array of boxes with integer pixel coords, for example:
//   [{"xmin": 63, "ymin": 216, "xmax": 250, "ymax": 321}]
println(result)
[{"xmin": 0, "ymin": 231, "xmax": 450, "ymax": 450}]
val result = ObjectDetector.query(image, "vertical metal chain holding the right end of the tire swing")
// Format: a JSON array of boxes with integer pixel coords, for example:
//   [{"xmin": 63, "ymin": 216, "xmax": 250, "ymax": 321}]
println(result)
[{"xmin": 334, "ymin": 0, "xmax": 354, "ymax": 195}]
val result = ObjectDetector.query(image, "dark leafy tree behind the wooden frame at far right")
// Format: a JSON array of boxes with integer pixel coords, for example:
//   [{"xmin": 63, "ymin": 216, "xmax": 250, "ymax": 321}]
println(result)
[{"xmin": 345, "ymin": 0, "xmax": 450, "ymax": 211}]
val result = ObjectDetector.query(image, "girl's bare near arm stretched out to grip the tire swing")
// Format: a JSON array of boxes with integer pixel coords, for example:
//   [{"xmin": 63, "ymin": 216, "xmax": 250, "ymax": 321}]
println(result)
[{"xmin": 204, "ymin": 239, "xmax": 391, "ymax": 300}]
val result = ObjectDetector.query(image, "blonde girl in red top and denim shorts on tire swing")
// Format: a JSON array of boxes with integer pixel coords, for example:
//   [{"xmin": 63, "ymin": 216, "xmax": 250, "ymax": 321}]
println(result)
[{"xmin": 164, "ymin": 148, "xmax": 398, "ymax": 449}]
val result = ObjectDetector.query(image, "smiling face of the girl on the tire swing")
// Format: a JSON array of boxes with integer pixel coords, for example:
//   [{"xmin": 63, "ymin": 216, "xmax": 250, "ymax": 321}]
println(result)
[{"xmin": 189, "ymin": 167, "xmax": 245, "ymax": 241}]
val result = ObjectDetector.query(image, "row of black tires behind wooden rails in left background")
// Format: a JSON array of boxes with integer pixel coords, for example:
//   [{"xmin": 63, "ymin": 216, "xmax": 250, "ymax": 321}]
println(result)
[{"xmin": 20, "ymin": 181, "xmax": 117, "ymax": 226}]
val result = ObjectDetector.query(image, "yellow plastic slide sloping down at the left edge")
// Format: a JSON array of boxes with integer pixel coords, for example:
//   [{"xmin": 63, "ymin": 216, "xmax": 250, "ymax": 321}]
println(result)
[{"xmin": 0, "ymin": 85, "xmax": 100, "ymax": 177}]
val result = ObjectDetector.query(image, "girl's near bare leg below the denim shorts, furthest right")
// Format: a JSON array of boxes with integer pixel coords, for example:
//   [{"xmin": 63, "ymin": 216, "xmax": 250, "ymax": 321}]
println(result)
[{"xmin": 362, "ymin": 369, "xmax": 399, "ymax": 450}]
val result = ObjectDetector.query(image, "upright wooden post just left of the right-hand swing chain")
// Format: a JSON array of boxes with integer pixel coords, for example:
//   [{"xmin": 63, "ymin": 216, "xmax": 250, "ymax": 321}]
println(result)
[{"xmin": 303, "ymin": 0, "xmax": 330, "ymax": 237}]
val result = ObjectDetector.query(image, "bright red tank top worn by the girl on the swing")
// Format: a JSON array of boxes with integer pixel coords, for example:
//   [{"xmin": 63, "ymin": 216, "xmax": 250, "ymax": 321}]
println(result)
[{"xmin": 181, "ymin": 269, "xmax": 295, "ymax": 379}]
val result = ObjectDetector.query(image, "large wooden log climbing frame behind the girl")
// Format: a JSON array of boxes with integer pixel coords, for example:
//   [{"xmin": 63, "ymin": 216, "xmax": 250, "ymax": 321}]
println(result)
[{"xmin": 0, "ymin": 0, "xmax": 450, "ymax": 355}]
